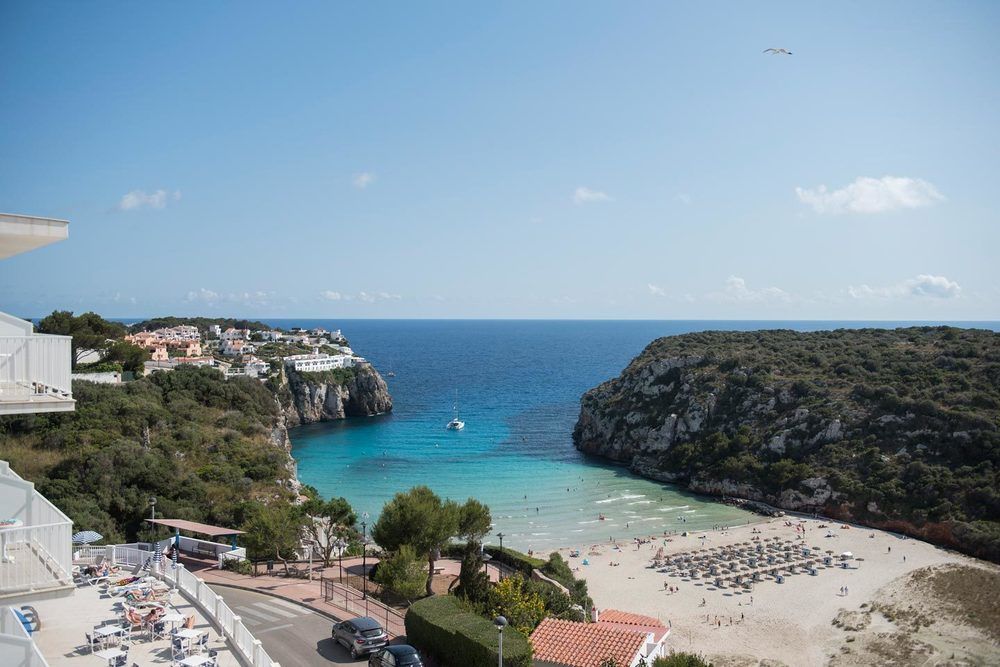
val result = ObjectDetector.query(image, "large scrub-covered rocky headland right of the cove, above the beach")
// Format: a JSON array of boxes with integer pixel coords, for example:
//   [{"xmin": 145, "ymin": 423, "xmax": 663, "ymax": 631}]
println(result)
[{"xmin": 573, "ymin": 327, "xmax": 1000, "ymax": 561}]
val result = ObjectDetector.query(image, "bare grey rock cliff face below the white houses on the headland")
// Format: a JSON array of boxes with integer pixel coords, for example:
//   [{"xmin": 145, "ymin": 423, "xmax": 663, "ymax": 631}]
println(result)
[{"xmin": 278, "ymin": 364, "xmax": 392, "ymax": 428}]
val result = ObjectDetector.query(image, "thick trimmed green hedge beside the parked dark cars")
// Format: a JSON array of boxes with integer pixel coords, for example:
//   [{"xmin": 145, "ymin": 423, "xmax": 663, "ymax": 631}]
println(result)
[{"xmin": 405, "ymin": 595, "xmax": 531, "ymax": 667}]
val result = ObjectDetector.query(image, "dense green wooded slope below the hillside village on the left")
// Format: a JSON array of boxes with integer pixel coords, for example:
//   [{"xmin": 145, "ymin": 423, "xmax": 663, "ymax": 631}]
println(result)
[{"xmin": 0, "ymin": 367, "xmax": 292, "ymax": 542}]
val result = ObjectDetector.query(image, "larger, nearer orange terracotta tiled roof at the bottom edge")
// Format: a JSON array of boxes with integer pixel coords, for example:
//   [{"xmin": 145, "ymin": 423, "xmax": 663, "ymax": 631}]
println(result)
[{"xmin": 531, "ymin": 618, "xmax": 646, "ymax": 667}]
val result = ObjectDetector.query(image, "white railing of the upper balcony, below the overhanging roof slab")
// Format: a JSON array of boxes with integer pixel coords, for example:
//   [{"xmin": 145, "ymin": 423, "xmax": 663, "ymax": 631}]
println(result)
[{"xmin": 0, "ymin": 334, "xmax": 73, "ymax": 401}]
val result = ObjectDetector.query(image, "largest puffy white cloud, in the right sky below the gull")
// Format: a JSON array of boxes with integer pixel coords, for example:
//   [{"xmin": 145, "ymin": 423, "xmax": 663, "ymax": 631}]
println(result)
[{"xmin": 795, "ymin": 176, "xmax": 944, "ymax": 215}]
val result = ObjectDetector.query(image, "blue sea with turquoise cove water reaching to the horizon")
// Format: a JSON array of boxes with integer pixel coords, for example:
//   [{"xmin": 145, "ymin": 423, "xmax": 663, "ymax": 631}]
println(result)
[{"xmin": 268, "ymin": 319, "xmax": 997, "ymax": 552}]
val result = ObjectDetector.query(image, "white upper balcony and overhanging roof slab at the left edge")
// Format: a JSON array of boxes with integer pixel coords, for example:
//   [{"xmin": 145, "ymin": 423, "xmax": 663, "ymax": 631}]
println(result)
[{"xmin": 0, "ymin": 213, "xmax": 76, "ymax": 415}]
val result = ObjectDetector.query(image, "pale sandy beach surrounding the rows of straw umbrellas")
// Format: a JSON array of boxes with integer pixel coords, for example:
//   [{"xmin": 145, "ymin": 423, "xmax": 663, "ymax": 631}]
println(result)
[{"xmin": 561, "ymin": 516, "xmax": 998, "ymax": 666}]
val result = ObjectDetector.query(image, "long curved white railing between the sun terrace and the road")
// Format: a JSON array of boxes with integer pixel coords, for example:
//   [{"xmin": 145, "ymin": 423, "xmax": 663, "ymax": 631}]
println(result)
[{"xmin": 98, "ymin": 545, "xmax": 281, "ymax": 667}]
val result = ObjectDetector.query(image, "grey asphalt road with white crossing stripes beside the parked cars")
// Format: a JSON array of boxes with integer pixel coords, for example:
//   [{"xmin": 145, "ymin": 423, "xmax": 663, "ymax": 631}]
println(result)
[{"xmin": 212, "ymin": 586, "xmax": 368, "ymax": 667}]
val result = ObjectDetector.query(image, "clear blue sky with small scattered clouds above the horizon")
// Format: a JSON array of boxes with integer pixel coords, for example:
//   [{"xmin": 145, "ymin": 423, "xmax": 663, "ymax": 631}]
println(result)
[{"xmin": 0, "ymin": 0, "xmax": 1000, "ymax": 320}]
